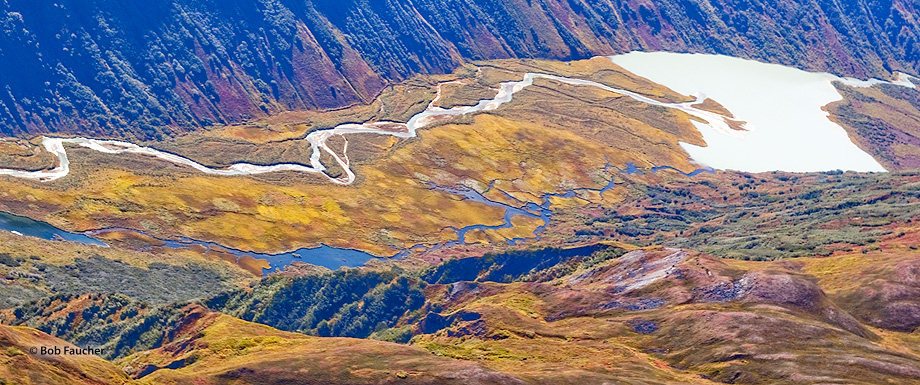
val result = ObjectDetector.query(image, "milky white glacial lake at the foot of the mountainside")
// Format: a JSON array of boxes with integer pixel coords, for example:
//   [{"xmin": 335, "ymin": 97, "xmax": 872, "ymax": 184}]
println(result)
[{"xmin": 611, "ymin": 52, "xmax": 886, "ymax": 172}]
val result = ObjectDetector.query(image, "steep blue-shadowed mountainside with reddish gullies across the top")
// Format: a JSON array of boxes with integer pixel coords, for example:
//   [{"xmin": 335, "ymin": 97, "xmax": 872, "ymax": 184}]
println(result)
[{"xmin": 0, "ymin": 0, "xmax": 920, "ymax": 139}]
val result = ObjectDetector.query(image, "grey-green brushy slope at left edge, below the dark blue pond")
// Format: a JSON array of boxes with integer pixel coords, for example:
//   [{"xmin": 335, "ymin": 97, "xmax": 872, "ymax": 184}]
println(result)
[{"xmin": 0, "ymin": 232, "xmax": 253, "ymax": 308}]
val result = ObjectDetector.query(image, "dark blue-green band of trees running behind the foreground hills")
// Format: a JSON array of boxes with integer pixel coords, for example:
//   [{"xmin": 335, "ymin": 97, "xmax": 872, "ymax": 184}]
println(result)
[{"xmin": 0, "ymin": 244, "xmax": 624, "ymax": 359}]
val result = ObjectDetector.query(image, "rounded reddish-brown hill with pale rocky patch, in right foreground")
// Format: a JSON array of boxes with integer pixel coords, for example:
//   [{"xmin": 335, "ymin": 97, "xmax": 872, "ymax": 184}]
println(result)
[{"xmin": 413, "ymin": 249, "xmax": 920, "ymax": 384}]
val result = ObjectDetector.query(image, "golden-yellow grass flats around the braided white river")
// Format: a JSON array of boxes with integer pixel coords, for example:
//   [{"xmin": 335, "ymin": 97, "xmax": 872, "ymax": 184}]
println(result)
[{"xmin": 0, "ymin": 59, "xmax": 701, "ymax": 256}]
